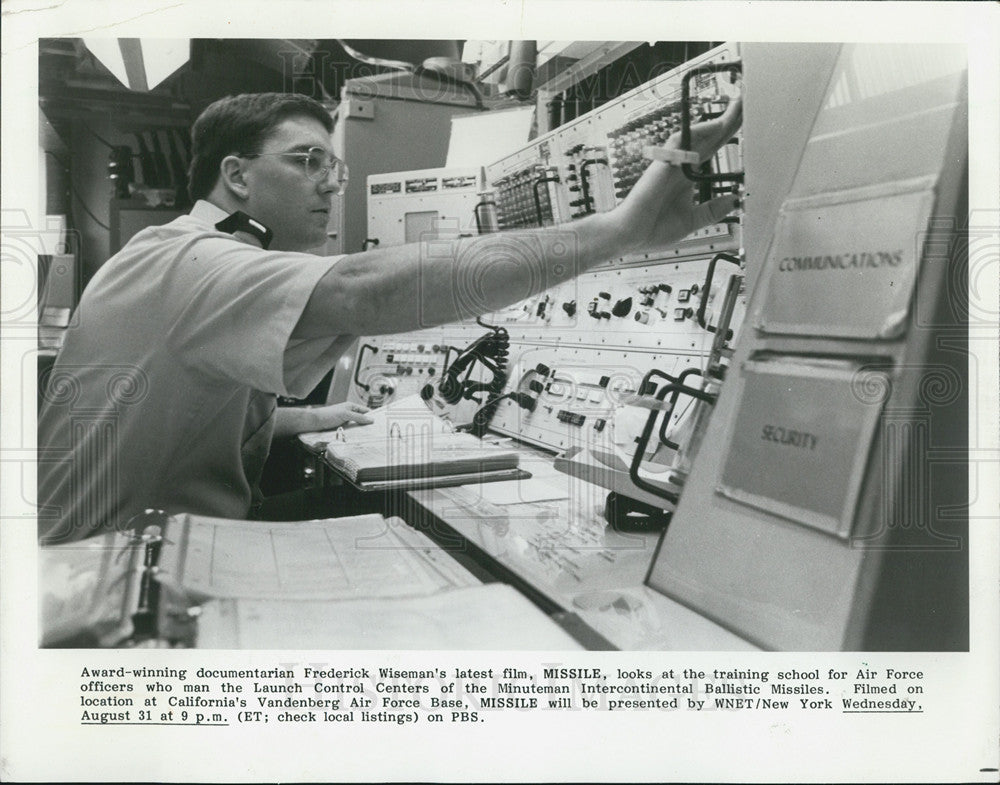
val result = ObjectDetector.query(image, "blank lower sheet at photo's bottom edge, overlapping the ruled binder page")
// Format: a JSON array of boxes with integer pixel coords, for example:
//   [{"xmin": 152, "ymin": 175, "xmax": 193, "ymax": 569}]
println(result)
[{"xmin": 198, "ymin": 583, "xmax": 582, "ymax": 651}]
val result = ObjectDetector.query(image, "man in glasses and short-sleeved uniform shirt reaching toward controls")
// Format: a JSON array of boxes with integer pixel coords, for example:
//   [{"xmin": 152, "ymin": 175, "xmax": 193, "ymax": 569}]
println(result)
[{"xmin": 38, "ymin": 94, "xmax": 740, "ymax": 542}]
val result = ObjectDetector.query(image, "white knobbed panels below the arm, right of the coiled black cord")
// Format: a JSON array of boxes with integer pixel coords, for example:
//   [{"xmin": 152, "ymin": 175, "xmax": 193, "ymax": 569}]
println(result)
[{"xmin": 484, "ymin": 257, "xmax": 745, "ymax": 456}]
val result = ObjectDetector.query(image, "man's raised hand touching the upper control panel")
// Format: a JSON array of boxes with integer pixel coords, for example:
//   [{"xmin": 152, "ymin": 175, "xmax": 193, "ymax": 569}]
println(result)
[{"xmin": 611, "ymin": 97, "xmax": 743, "ymax": 253}]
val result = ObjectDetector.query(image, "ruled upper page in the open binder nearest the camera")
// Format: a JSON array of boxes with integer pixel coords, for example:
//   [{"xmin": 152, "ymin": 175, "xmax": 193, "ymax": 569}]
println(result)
[{"xmin": 159, "ymin": 515, "xmax": 454, "ymax": 600}]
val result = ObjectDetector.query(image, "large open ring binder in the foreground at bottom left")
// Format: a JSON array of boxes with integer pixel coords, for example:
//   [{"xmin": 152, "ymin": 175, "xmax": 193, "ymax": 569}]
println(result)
[{"xmin": 39, "ymin": 511, "xmax": 579, "ymax": 649}]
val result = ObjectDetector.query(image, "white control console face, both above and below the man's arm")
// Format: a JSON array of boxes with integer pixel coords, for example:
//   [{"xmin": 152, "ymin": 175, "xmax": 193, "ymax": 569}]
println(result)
[{"xmin": 332, "ymin": 45, "xmax": 746, "ymax": 508}]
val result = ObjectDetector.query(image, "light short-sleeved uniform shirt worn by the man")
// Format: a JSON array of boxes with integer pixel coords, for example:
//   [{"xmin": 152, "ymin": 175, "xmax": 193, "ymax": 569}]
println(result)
[{"xmin": 38, "ymin": 201, "xmax": 351, "ymax": 542}]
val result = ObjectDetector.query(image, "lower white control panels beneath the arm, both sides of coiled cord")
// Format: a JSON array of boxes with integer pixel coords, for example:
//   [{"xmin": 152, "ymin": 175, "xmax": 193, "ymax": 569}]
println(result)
[{"xmin": 340, "ymin": 254, "xmax": 745, "ymax": 478}]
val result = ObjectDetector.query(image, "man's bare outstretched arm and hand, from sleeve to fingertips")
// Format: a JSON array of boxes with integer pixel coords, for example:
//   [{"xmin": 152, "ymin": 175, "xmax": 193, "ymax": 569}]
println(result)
[{"xmin": 294, "ymin": 98, "xmax": 742, "ymax": 338}]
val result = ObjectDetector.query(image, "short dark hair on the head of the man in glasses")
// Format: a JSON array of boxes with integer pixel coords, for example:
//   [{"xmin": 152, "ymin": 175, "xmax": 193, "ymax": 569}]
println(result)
[{"xmin": 188, "ymin": 93, "xmax": 333, "ymax": 199}]
